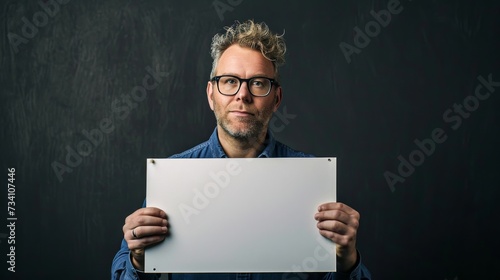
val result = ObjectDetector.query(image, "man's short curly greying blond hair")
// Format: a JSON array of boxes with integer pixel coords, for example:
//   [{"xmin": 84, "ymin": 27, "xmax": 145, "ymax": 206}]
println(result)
[{"xmin": 210, "ymin": 20, "xmax": 286, "ymax": 81}]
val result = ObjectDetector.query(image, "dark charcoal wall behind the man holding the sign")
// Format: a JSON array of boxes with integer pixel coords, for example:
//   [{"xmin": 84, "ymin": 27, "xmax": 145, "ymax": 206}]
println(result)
[{"xmin": 0, "ymin": 0, "xmax": 500, "ymax": 280}]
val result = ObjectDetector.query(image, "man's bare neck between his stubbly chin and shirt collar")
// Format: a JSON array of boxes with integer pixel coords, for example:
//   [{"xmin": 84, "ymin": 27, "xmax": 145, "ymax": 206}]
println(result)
[{"xmin": 217, "ymin": 127, "xmax": 267, "ymax": 158}]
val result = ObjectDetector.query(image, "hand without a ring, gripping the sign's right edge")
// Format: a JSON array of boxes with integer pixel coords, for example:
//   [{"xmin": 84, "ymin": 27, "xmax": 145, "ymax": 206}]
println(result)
[{"xmin": 314, "ymin": 202, "xmax": 359, "ymax": 271}]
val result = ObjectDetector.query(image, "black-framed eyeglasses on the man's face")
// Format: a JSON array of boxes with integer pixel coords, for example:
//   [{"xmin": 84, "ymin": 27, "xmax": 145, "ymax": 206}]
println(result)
[{"xmin": 210, "ymin": 75, "xmax": 279, "ymax": 97}]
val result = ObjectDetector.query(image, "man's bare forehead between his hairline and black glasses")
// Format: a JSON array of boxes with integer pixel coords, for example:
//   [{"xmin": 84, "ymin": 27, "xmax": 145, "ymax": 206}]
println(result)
[{"xmin": 216, "ymin": 44, "xmax": 274, "ymax": 78}]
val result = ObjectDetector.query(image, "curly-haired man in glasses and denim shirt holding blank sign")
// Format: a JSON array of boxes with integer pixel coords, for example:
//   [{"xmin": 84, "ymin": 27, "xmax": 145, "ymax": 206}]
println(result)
[{"xmin": 112, "ymin": 21, "xmax": 371, "ymax": 279}]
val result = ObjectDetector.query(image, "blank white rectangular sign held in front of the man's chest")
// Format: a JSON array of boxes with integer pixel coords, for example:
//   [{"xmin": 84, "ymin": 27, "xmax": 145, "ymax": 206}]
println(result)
[{"xmin": 145, "ymin": 157, "xmax": 336, "ymax": 273}]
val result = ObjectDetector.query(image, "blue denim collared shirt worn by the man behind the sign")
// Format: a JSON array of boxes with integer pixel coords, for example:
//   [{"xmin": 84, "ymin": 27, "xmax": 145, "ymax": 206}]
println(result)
[{"xmin": 111, "ymin": 128, "xmax": 371, "ymax": 280}]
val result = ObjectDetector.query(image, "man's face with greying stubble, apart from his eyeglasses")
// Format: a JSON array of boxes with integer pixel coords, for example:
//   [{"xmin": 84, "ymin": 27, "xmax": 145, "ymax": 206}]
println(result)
[{"xmin": 207, "ymin": 44, "xmax": 282, "ymax": 140}]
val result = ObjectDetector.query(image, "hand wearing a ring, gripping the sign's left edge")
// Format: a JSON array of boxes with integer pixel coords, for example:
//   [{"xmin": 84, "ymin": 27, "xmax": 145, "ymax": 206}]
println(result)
[{"xmin": 123, "ymin": 207, "xmax": 168, "ymax": 271}]
